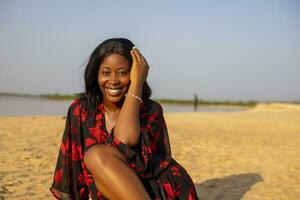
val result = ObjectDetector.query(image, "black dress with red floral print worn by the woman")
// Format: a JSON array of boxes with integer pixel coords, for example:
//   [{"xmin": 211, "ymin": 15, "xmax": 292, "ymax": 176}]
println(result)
[{"xmin": 50, "ymin": 99, "xmax": 198, "ymax": 200}]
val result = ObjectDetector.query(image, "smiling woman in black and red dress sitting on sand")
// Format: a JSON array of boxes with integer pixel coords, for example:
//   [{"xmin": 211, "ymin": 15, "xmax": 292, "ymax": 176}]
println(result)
[{"xmin": 50, "ymin": 38, "xmax": 197, "ymax": 200}]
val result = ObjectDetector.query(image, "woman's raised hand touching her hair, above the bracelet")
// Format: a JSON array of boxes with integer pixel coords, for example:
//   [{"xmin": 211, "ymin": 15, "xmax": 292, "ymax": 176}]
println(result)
[{"xmin": 130, "ymin": 47, "xmax": 149, "ymax": 86}]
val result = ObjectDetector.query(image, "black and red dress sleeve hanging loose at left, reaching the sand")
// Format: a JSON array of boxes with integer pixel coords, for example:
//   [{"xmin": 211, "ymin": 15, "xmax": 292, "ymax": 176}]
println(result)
[{"xmin": 50, "ymin": 106, "xmax": 89, "ymax": 200}]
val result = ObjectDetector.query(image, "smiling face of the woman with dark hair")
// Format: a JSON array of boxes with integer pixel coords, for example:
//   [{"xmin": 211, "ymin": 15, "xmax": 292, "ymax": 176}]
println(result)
[{"xmin": 98, "ymin": 53, "xmax": 130, "ymax": 103}]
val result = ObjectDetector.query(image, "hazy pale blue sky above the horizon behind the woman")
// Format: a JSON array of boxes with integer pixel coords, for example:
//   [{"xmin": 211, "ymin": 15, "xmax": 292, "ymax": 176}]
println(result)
[{"xmin": 0, "ymin": 0, "xmax": 300, "ymax": 101}]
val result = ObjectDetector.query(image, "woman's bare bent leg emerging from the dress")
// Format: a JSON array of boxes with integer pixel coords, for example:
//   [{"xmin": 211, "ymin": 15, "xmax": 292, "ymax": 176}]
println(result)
[{"xmin": 84, "ymin": 145, "xmax": 150, "ymax": 200}]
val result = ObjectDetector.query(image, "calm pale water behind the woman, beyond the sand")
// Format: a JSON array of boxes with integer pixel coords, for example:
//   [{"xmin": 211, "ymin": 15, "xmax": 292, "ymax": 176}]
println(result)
[{"xmin": 0, "ymin": 96, "xmax": 245, "ymax": 116}]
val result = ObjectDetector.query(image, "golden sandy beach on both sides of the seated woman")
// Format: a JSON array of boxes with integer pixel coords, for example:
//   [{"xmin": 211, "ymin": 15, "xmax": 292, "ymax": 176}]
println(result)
[{"xmin": 0, "ymin": 104, "xmax": 300, "ymax": 200}]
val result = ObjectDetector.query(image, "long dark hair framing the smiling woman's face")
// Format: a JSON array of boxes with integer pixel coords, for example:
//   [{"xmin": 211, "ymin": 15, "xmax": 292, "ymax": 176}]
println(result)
[{"xmin": 78, "ymin": 38, "xmax": 152, "ymax": 110}]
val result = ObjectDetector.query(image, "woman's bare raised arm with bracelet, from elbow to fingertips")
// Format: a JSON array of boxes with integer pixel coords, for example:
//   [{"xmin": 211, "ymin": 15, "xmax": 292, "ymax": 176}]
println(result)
[{"xmin": 114, "ymin": 48, "xmax": 148, "ymax": 146}]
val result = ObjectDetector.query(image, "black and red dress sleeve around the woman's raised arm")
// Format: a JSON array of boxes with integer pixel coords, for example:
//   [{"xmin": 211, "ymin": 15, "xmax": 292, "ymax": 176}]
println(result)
[{"xmin": 112, "ymin": 102, "xmax": 171, "ymax": 178}]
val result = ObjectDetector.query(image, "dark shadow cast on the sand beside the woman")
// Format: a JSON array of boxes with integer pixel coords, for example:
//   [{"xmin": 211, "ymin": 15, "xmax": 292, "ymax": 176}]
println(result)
[{"xmin": 196, "ymin": 173, "xmax": 263, "ymax": 200}]
